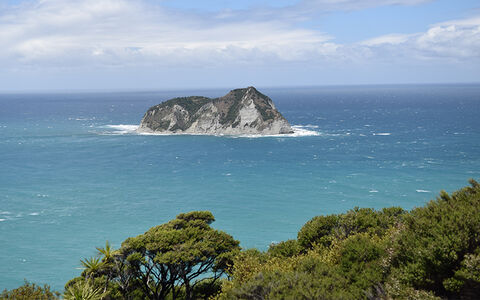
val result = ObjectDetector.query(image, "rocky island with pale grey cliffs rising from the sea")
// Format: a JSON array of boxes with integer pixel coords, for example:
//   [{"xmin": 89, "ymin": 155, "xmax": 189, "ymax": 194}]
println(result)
[{"xmin": 138, "ymin": 87, "xmax": 293, "ymax": 135}]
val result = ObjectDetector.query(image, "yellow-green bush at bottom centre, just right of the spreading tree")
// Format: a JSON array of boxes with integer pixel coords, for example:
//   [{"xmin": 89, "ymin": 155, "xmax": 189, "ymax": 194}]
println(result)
[{"xmin": 217, "ymin": 250, "xmax": 355, "ymax": 299}]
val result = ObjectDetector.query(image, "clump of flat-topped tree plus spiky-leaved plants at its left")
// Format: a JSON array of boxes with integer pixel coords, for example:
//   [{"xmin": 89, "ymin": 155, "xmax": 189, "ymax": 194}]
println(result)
[{"xmin": 66, "ymin": 211, "xmax": 240, "ymax": 299}]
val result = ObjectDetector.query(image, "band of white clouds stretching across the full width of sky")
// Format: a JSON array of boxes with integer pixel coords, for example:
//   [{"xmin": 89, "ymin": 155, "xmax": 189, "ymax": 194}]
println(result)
[{"xmin": 0, "ymin": 0, "xmax": 480, "ymax": 80}]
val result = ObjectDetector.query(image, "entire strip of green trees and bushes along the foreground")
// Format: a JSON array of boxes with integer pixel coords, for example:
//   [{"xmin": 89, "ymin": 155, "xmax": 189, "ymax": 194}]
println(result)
[{"xmin": 0, "ymin": 180, "xmax": 480, "ymax": 300}]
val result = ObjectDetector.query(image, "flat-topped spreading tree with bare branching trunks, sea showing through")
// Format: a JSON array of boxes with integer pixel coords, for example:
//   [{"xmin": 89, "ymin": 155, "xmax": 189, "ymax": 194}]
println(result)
[{"xmin": 119, "ymin": 212, "xmax": 239, "ymax": 299}]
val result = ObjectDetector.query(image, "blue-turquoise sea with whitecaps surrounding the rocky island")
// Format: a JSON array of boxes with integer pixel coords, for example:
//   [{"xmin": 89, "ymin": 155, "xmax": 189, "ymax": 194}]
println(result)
[{"xmin": 0, "ymin": 85, "xmax": 480, "ymax": 290}]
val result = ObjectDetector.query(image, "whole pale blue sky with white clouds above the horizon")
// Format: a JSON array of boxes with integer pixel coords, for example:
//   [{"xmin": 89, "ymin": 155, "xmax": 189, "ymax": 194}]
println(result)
[{"xmin": 0, "ymin": 0, "xmax": 480, "ymax": 91}]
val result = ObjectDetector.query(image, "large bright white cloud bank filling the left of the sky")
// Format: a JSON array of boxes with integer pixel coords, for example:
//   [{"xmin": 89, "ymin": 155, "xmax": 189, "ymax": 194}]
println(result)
[{"xmin": 0, "ymin": 0, "xmax": 329, "ymax": 66}]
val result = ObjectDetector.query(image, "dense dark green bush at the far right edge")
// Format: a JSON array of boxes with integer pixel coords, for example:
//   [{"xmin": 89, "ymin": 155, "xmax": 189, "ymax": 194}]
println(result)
[{"xmin": 395, "ymin": 180, "xmax": 480, "ymax": 295}]
